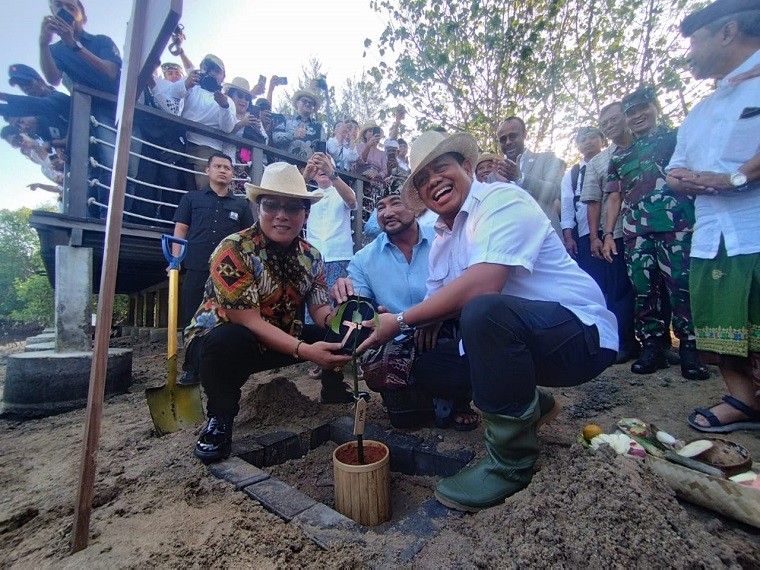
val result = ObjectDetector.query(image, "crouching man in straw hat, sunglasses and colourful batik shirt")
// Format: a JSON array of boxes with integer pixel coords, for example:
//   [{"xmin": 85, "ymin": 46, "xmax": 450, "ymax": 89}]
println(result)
[{"xmin": 185, "ymin": 162, "xmax": 351, "ymax": 462}]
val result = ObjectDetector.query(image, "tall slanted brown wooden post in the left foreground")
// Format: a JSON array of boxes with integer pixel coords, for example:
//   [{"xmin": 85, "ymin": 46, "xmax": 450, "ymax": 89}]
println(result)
[{"xmin": 71, "ymin": 0, "xmax": 147, "ymax": 552}]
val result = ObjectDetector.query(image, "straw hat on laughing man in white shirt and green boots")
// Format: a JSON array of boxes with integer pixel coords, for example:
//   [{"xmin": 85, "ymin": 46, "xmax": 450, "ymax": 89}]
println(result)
[{"xmin": 401, "ymin": 131, "xmax": 478, "ymax": 213}]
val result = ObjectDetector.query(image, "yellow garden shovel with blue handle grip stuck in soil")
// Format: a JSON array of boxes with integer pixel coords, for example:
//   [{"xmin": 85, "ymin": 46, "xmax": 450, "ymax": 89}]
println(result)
[{"xmin": 145, "ymin": 235, "xmax": 205, "ymax": 435}]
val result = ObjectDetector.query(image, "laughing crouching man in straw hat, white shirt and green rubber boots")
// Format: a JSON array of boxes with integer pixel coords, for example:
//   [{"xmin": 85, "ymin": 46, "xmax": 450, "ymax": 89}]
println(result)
[{"xmin": 360, "ymin": 132, "xmax": 618, "ymax": 511}]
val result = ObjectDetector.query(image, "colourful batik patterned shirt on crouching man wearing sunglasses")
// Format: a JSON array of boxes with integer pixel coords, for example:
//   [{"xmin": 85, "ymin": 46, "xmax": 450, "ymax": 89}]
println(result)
[{"xmin": 185, "ymin": 222, "xmax": 329, "ymax": 351}]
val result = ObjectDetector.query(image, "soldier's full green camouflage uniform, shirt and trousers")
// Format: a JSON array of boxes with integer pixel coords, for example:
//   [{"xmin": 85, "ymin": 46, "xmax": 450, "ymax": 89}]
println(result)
[{"xmin": 607, "ymin": 127, "xmax": 694, "ymax": 341}]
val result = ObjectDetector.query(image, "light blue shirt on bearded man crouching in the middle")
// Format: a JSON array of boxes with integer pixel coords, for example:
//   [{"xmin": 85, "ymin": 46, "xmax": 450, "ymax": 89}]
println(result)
[{"xmin": 348, "ymin": 222, "xmax": 435, "ymax": 313}]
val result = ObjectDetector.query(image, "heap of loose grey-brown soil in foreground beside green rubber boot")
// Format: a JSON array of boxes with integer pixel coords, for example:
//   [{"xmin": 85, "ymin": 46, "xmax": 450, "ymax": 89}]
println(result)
[{"xmin": 415, "ymin": 445, "xmax": 760, "ymax": 568}]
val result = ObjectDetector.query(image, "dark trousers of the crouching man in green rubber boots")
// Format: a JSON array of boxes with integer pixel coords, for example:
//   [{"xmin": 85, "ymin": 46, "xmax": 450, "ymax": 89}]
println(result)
[{"xmin": 413, "ymin": 295, "xmax": 616, "ymax": 415}]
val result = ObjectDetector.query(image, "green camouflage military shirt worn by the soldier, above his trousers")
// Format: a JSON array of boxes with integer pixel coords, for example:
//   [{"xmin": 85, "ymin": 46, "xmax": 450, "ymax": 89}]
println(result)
[{"xmin": 605, "ymin": 127, "xmax": 694, "ymax": 238}]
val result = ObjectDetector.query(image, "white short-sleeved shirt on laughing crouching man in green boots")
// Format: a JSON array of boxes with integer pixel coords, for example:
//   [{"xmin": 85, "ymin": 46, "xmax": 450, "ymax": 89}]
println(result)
[{"xmin": 427, "ymin": 182, "xmax": 618, "ymax": 351}]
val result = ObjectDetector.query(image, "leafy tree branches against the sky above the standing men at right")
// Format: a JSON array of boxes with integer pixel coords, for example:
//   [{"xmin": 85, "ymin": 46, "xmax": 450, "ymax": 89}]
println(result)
[{"xmin": 365, "ymin": 0, "xmax": 708, "ymax": 154}]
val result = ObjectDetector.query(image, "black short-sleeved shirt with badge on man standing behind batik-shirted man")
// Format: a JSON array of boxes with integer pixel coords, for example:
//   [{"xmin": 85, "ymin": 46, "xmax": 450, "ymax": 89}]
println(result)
[{"xmin": 174, "ymin": 187, "xmax": 253, "ymax": 271}]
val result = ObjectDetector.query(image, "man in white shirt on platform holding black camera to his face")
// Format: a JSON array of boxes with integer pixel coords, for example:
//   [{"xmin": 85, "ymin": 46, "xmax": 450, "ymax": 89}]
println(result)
[{"xmin": 155, "ymin": 54, "xmax": 238, "ymax": 189}]
